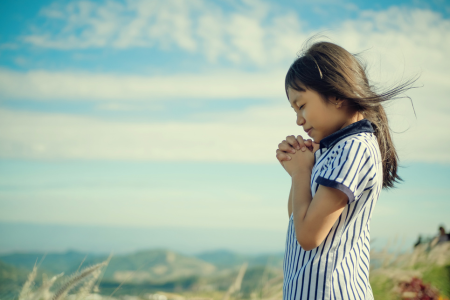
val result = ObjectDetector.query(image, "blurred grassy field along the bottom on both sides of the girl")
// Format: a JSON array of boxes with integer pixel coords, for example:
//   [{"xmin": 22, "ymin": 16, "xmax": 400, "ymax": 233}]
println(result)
[{"xmin": 2, "ymin": 242, "xmax": 450, "ymax": 300}]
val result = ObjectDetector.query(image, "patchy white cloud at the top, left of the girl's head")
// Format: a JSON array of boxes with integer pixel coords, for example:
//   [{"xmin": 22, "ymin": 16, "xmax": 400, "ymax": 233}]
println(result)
[{"xmin": 22, "ymin": 0, "xmax": 305, "ymax": 66}]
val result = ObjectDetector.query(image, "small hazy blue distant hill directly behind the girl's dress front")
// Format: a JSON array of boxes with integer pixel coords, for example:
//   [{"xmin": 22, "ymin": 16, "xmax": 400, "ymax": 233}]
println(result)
[{"xmin": 195, "ymin": 250, "xmax": 284, "ymax": 268}]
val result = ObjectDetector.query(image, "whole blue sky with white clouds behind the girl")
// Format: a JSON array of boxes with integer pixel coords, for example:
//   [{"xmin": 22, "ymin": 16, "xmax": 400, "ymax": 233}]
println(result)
[{"xmin": 0, "ymin": 0, "xmax": 450, "ymax": 252}]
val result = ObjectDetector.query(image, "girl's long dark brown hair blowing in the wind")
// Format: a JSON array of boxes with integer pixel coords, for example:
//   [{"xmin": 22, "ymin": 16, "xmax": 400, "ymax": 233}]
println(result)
[{"xmin": 285, "ymin": 39, "xmax": 420, "ymax": 188}]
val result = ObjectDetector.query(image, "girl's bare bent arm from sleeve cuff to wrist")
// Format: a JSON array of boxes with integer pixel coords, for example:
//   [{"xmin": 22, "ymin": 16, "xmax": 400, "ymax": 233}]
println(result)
[{"xmin": 291, "ymin": 172, "xmax": 348, "ymax": 251}]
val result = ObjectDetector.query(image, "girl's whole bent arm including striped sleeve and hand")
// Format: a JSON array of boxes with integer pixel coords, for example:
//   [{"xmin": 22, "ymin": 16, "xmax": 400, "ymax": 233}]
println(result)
[{"xmin": 283, "ymin": 140, "xmax": 370, "ymax": 251}]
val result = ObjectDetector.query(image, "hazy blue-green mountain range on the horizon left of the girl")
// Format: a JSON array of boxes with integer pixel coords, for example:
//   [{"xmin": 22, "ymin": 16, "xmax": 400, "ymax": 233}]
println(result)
[{"xmin": 0, "ymin": 249, "xmax": 283, "ymax": 284}]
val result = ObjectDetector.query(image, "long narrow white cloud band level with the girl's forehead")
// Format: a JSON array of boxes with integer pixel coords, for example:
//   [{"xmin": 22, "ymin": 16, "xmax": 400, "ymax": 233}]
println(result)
[{"xmin": 0, "ymin": 69, "xmax": 285, "ymax": 102}]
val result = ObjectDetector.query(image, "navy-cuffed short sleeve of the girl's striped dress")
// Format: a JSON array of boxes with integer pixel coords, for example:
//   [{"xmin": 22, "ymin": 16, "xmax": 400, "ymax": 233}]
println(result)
[{"xmin": 316, "ymin": 139, "xmax": 376, "ymax": 204}]
